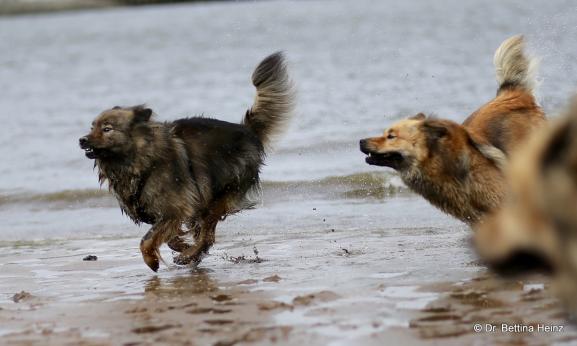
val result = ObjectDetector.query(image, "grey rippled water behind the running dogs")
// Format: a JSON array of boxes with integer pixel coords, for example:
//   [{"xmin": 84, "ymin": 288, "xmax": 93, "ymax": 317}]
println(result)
[{"xmin": 0, "ymin": 0, "xmax": 577, "ymax": 241}]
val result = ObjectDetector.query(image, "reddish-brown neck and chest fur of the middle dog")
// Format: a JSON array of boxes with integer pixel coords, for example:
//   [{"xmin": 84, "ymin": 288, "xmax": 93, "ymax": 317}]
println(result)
[{"xmin": 399, "ymin": 127, "xmax": 505, "ymax": 224}]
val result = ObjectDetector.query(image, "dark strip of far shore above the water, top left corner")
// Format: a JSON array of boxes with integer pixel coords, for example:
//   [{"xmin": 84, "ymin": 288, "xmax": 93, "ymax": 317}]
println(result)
[{"xmin": 0, "ymin": 0, "xmax": 222, "ymax": 16}]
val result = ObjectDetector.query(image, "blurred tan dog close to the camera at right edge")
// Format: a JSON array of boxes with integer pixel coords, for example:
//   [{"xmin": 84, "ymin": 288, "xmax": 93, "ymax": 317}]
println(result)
[{"xmin": 474, "ymin": 97, "xmax": 577, "ymax": 313}]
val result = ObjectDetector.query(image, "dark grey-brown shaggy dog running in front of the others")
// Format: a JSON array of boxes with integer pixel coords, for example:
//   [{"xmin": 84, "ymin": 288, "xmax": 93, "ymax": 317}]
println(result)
[{"xmin": 80, "ymin": 52, "xmax": 295, "ymax": 271}]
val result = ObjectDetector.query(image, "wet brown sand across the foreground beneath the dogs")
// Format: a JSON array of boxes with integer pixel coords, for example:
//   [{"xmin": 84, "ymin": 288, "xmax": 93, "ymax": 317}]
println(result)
[{"xmin": 0, "ymin": 220, "xmax": 577, "ymax": 345}]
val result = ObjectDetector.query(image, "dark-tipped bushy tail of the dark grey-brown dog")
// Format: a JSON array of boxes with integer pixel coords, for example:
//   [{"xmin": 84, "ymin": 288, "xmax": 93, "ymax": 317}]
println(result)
[{"xmin": 243, "ymin": 52, "xmax": 295, "ymax": 147}]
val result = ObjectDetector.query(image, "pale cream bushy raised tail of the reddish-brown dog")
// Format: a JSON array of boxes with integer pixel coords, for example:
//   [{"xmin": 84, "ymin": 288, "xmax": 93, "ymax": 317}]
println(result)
[{"xmin": 493, "ymin": 35, "xmax": 539, "ymax": 95}]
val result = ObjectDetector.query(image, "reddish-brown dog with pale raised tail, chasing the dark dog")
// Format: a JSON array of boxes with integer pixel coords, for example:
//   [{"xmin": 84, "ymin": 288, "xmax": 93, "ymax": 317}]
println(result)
[{"xmin": 360, "ymin": 36, "xmax": 546, "ymax": 226}]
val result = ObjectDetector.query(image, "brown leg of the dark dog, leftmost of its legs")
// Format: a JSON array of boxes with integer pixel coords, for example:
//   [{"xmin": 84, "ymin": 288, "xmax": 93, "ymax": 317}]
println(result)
[{"xmin": 140, "ymin": 221, "xmax": 181, "ymax": 271}]
